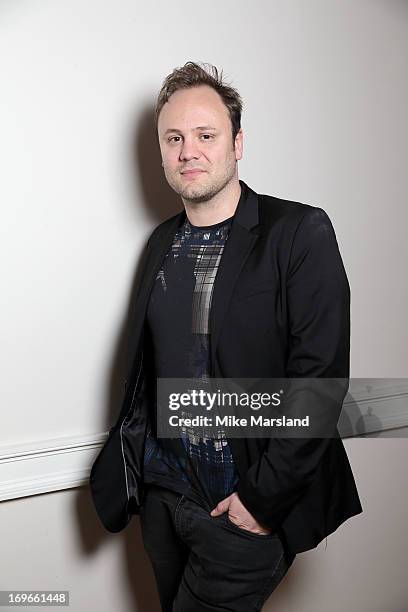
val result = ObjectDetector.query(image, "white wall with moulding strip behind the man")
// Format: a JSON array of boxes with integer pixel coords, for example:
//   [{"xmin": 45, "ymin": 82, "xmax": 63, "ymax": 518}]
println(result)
[{"xmin": 0, "ymin": 0, "xmax": 408, "ymax": 612}]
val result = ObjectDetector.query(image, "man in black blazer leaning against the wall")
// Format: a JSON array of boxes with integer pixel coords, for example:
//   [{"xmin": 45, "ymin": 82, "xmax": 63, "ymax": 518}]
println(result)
[{"xmin": 91, "ymin": 62, "xmax": 362, "ymax": 612}]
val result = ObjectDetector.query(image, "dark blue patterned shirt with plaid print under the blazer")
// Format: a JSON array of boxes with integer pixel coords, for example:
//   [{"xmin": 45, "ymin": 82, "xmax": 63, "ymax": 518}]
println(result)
[{"xmin": 144, "ymin": 217, "xmax": 238, "ymax": 509}]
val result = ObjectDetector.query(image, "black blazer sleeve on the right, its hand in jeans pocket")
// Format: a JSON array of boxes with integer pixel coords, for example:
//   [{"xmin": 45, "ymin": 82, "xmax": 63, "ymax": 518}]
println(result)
[{"xmin": 237, "ymin": 207, "xmax": 350, "ymax": 530}]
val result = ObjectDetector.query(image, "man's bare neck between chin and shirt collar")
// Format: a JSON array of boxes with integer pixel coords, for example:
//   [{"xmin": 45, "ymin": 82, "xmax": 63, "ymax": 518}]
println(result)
[{"xmin": 183, "ymin": 179, "xmax": 241, "ymax": 227}]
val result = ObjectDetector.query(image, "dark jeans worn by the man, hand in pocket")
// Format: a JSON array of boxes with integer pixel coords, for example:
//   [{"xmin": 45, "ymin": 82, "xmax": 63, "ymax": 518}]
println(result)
[{"xmin": 140, "ymin": 484, "xmax": 295, "ymax": 612}]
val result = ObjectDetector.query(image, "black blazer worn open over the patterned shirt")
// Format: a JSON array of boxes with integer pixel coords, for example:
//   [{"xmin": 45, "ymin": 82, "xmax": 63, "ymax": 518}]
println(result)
[{"xmin": 90, "ymin": 181, "xmax": 362, "ymax": 553}]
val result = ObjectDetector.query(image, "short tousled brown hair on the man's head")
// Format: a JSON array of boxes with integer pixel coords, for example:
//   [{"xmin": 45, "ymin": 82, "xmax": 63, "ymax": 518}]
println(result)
[{"xmin": 154, "ymin": 62, "xmax": 242, "ymax": 142}]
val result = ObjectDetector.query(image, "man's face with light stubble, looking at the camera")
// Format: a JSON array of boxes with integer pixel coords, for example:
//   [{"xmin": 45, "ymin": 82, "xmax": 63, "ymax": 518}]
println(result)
[{"xmin": 158, "ymin": 85, "xmax": 243, "ymax": 203}]
